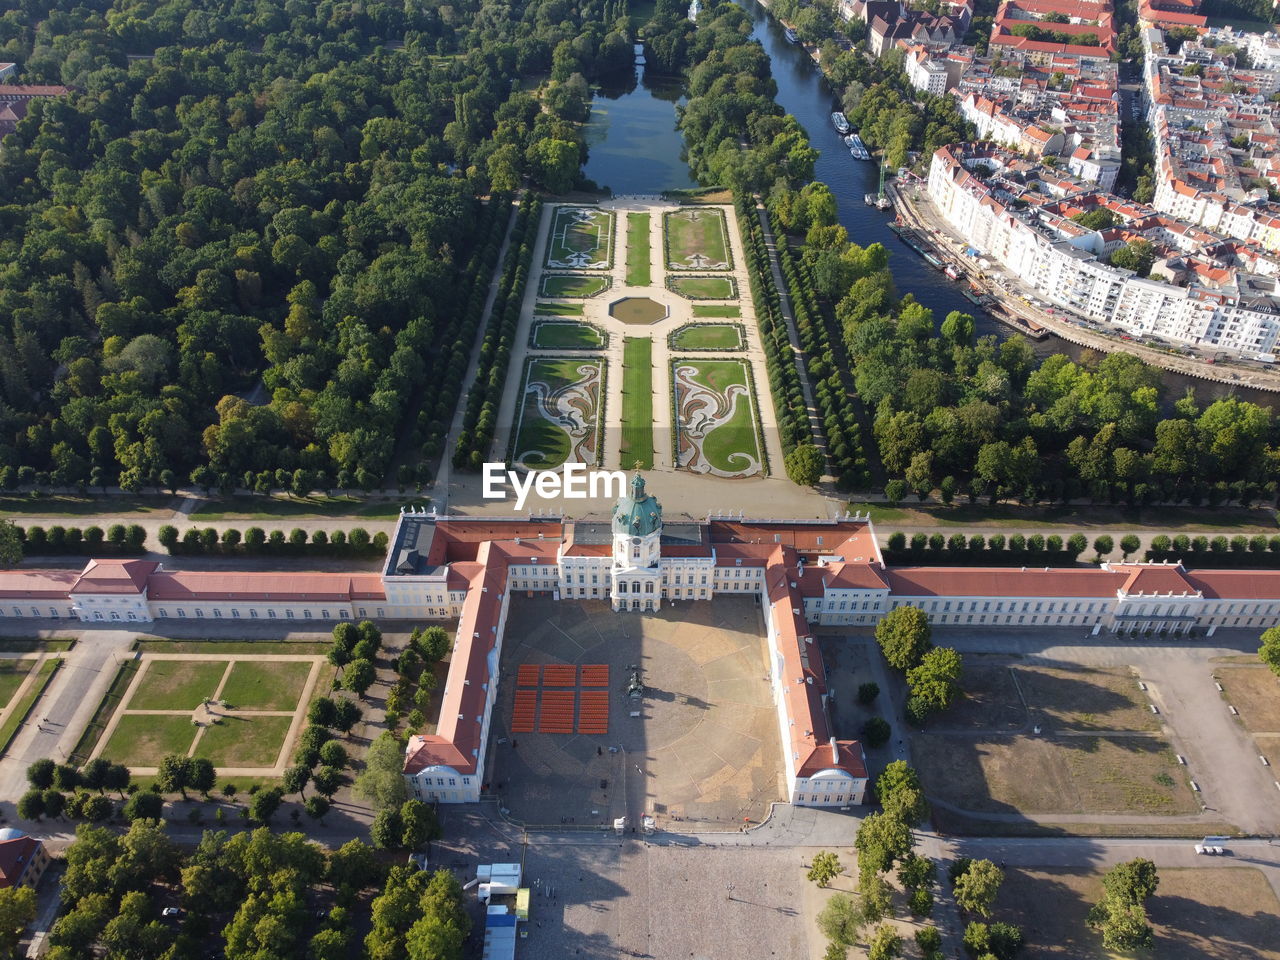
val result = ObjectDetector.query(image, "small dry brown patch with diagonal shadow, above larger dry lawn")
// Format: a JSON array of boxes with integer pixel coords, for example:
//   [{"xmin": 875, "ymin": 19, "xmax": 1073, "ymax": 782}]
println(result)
[{"xmin": 1012, "ymin": 666, "xmax": 1160, "ymax": 732}]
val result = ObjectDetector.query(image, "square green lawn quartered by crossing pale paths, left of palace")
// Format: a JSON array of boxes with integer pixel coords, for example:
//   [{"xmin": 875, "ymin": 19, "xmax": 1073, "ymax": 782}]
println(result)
[{"xmin": 92, "ymin": 653, "xmax": 325, "ymax": 776}]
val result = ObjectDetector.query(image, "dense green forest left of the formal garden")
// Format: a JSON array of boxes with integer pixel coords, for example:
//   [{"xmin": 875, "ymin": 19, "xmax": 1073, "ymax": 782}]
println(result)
[{"xmin": 0, "ymin": 0, "xmax": 631, "ymax": 492}]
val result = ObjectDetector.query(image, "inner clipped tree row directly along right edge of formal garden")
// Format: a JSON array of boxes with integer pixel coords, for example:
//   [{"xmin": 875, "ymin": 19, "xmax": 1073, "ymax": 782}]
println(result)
[{"xmin": 736, "ymin": 196, "xmax": 812, "ymax": 454}]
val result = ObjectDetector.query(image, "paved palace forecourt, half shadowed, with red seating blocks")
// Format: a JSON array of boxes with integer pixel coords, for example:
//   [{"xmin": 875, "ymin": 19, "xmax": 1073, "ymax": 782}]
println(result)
[{"xmin": 490, "ymin": 598, "xmax": 783, "ymax": 829}]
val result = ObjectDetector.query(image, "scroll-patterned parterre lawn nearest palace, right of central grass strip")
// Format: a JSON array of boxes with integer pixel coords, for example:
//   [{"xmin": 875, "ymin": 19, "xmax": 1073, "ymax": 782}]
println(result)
[{"xmin": 672, "ymin": 360, "xmax": 763, "ymax": 476}]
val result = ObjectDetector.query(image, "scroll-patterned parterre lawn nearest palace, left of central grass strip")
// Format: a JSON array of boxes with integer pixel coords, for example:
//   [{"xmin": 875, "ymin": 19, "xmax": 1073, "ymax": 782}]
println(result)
[{"xmin": 511, "ymin": 357, "xmax": 605, "ymax": 470}]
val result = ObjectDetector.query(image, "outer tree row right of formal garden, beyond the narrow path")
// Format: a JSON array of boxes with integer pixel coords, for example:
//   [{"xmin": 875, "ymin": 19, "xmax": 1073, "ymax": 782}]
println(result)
[{"xmin": 774, "ymin": 229, "xmax": 870, "ymax": 490}]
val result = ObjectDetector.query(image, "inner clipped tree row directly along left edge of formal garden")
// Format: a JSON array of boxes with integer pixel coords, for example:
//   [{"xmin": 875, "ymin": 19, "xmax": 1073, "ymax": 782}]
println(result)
[{"xmin": 453, "ymin": 196, "xmax": 543, "ymax": 472}]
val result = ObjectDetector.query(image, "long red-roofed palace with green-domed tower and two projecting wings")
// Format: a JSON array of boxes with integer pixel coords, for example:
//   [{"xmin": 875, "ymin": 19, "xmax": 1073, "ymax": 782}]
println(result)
[{"xmin": 0, "ymin": 474, "xmax": 1280, "ymax": 806}]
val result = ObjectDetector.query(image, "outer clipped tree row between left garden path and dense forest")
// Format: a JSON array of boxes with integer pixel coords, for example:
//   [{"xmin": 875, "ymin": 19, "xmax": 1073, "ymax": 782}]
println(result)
[{"xmin": 396, "ymin": 195, "xmax": 511, "ymax": 486}]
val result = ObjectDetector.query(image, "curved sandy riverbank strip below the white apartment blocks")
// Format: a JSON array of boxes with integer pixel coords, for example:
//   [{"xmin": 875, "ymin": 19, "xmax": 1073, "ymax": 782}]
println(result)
[{"xmin": 890, "ymin": 168, "xmax": 1280, "ymax": 393}]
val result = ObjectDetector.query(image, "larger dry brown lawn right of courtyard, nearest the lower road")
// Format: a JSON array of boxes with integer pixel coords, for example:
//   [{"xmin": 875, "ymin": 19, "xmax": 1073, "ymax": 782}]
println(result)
[{"xmin": 911, "ymin": 733, "xmax": 1199, "ymax": 819}]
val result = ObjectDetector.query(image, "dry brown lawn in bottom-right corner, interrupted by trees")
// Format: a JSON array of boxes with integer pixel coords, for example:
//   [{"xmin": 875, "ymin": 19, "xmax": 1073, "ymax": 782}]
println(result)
[{"xmin": 993, "ymin": 867, "xmax": 1280, "ymax": 960}]
